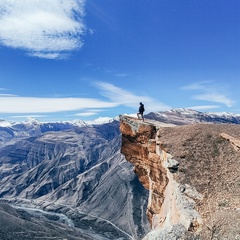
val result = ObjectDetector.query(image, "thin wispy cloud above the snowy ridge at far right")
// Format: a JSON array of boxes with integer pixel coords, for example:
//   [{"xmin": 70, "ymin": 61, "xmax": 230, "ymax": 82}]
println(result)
[{"xmin": 181, "ymin": 81, "xmax": 235, "ymax": 109}]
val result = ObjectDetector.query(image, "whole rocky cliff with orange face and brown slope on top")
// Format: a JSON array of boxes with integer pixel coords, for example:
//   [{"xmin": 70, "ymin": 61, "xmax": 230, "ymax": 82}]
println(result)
[{"xmin": 120, "ymin": 116, "xmax": 240, "ymax": 240}]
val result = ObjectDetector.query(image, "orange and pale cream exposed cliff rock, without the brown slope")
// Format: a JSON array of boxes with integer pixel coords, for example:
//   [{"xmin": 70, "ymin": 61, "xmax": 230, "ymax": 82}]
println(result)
[{"xmin": 120, "ymin": 116, "xmax": 202, "ymax": 239}]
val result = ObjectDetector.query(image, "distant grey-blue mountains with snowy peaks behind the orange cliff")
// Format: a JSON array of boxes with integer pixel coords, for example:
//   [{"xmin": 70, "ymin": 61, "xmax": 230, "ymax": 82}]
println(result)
[{"xmin": 0, "ymin": 109, "xmax": 240, "ymax": 239}]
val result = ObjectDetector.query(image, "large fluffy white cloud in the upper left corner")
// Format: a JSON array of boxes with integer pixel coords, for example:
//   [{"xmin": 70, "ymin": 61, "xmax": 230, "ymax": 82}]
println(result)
[{"xmin": 0, "ymin": 0, "xmax": 86, "ymax": 58}]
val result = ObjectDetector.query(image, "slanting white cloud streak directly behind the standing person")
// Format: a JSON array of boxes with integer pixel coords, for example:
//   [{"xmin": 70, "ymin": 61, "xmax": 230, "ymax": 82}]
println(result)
[{"xmin": 96, "ymin": 82, "xmax": 170, "ymax": 112}]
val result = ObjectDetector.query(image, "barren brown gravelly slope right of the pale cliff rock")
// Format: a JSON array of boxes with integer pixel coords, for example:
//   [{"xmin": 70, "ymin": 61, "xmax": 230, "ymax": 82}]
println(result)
[{"xmin": 159, "ymin": 124, "xmax": 240, "ymax": 239}]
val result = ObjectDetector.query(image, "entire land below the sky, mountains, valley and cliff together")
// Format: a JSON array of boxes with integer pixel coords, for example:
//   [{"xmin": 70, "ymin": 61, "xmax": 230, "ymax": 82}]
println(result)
[{"xmin": 0, "ymin": 109, "xmax": 240, "ymax": 240}]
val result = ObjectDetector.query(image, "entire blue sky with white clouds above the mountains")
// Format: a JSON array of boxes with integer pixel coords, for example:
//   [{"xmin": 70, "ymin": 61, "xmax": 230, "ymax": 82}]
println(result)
[{"xmin": 0, "ymin": 0, "xmax": 240, "ymax": 121}]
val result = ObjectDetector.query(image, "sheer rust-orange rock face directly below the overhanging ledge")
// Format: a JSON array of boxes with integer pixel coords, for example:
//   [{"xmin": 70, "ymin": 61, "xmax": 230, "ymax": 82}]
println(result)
[{"xmin": 120, "ymin": 117, "xmax": 169, "ymax": 225}]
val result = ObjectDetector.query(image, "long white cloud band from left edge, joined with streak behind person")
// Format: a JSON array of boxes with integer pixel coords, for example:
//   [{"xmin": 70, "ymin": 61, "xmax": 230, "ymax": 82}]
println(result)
[{"xmin": 0, "ymin": 82, "xmax": 170, "ymax": 117}]
